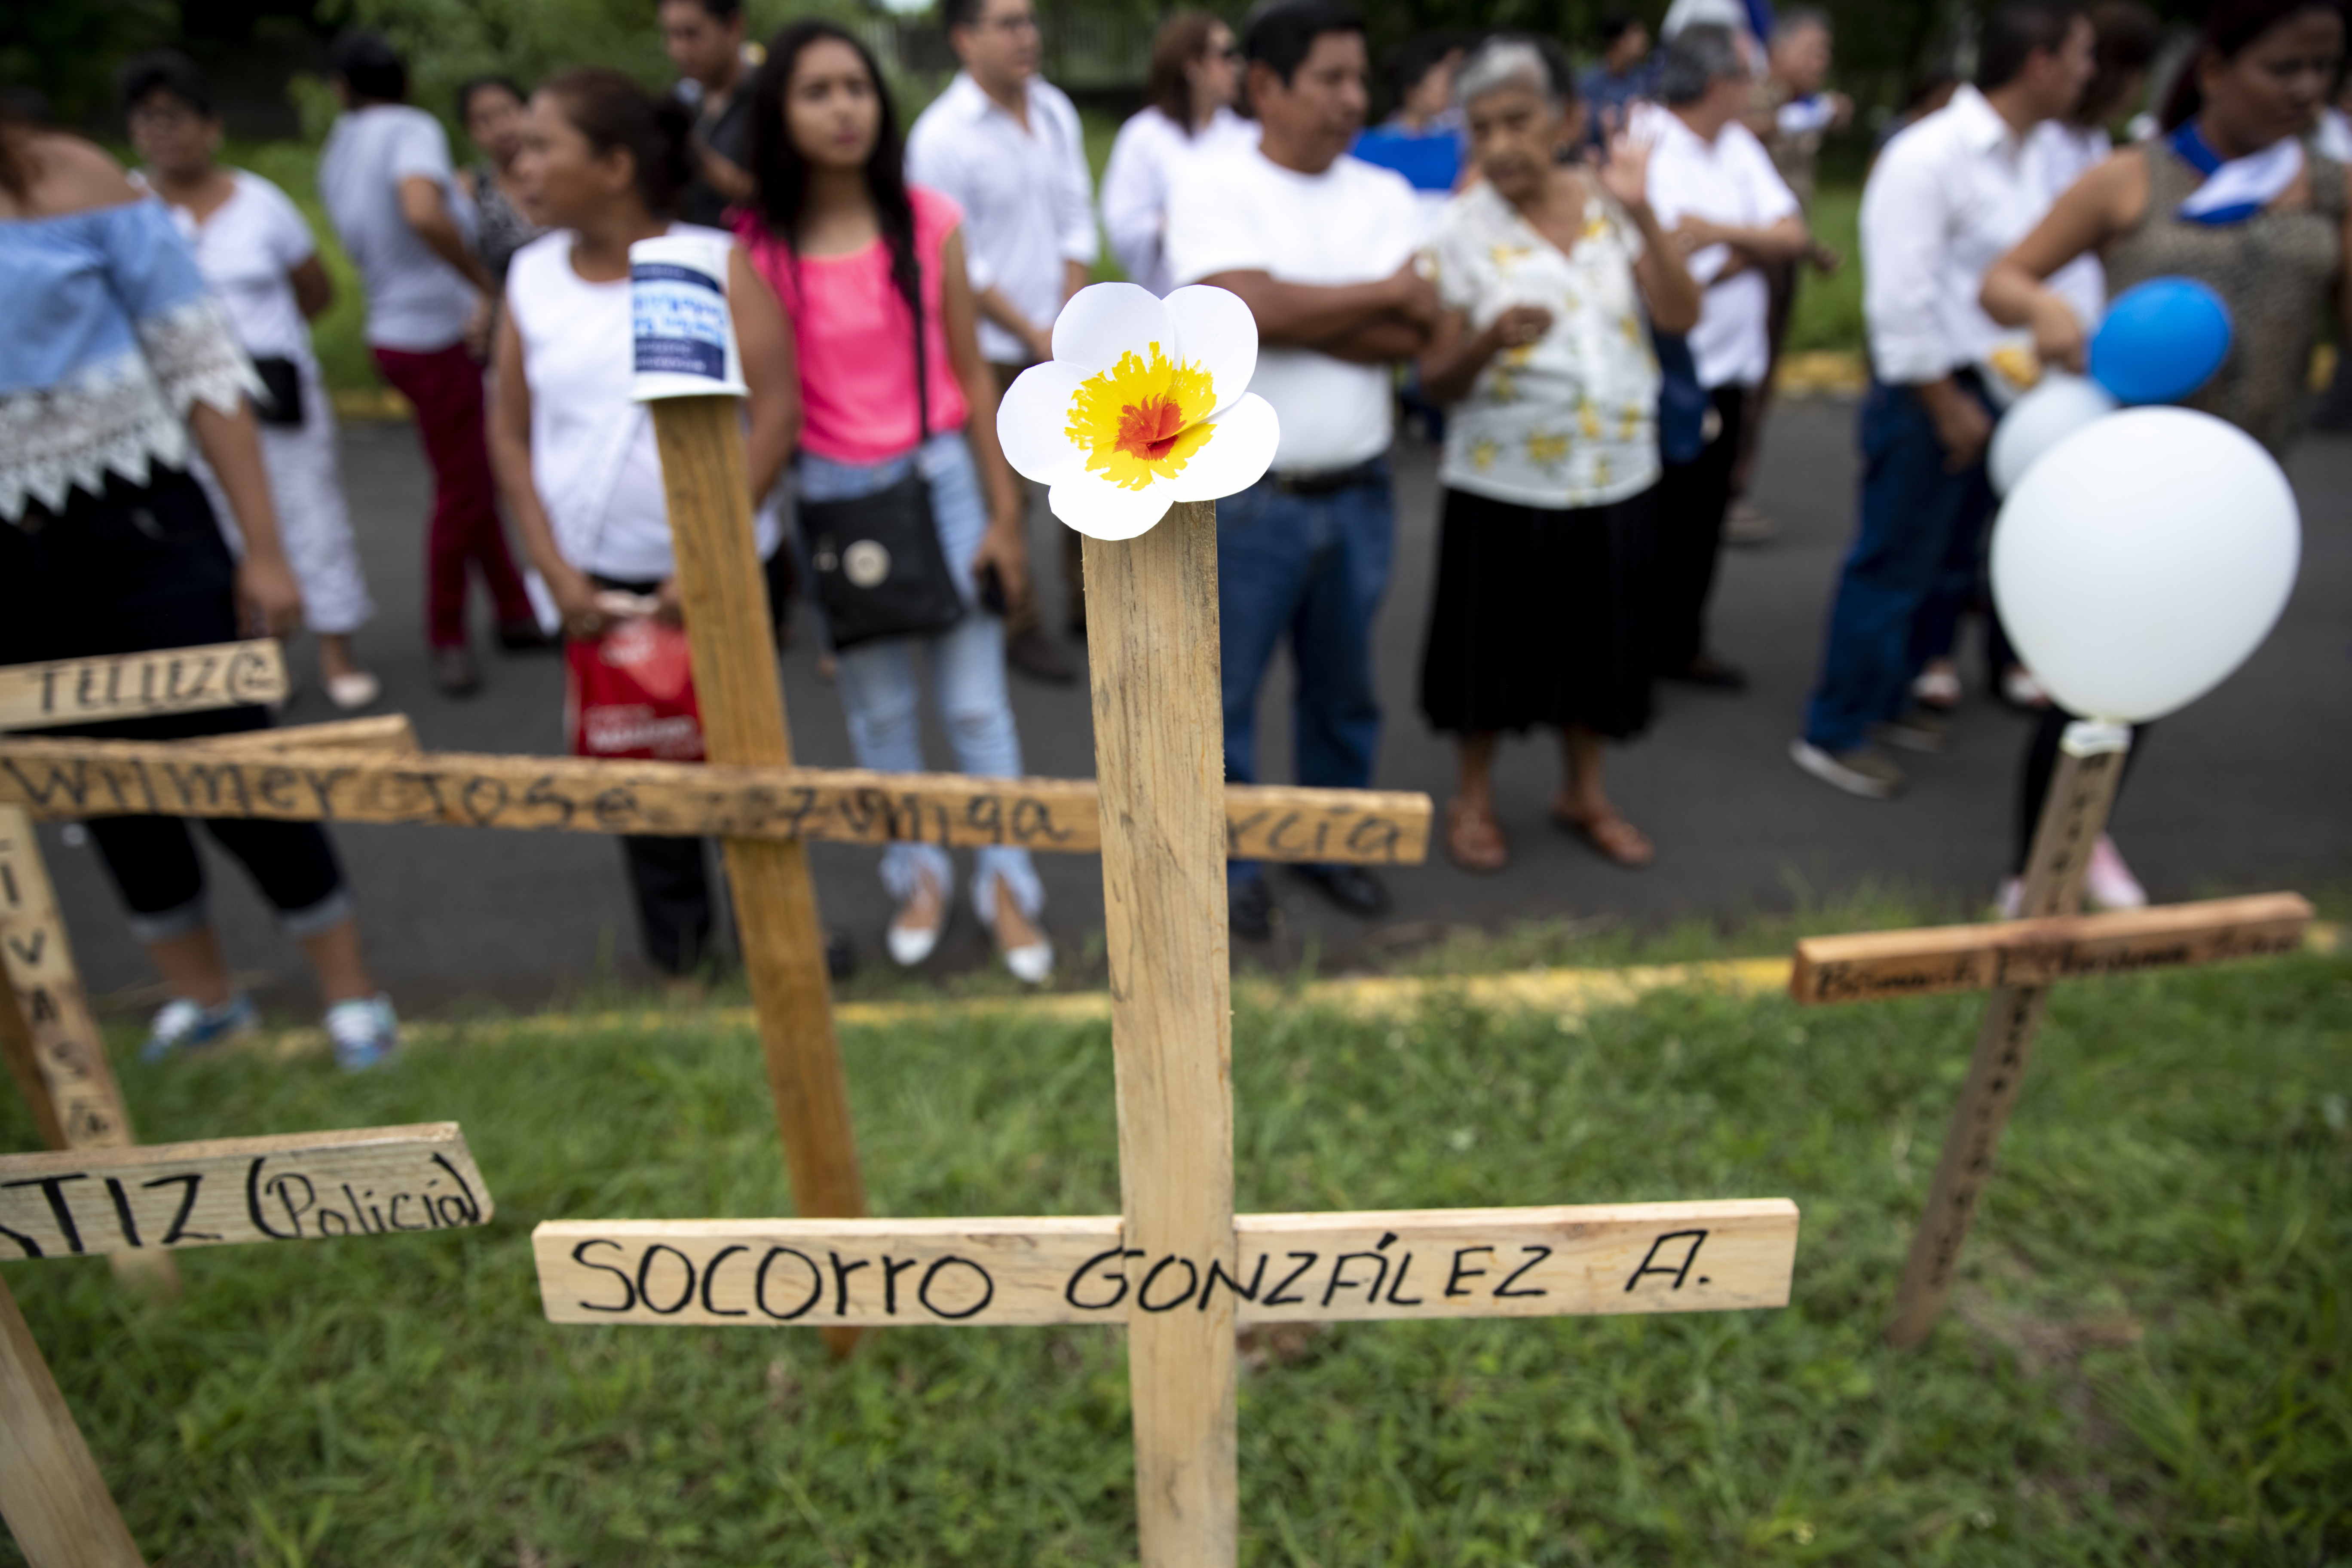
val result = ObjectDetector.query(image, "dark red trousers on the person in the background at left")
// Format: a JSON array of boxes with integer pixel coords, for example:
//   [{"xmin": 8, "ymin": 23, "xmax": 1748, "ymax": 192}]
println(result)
[{"xmin": 374, "ymin": 343, "xmax": 536, "ymax": 649}]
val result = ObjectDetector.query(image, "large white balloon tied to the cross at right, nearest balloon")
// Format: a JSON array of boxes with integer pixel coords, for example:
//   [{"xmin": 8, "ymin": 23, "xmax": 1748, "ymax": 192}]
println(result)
[{"xmin": 1992, "ymin": 407, "xmax": 2300, "ymax": 724}]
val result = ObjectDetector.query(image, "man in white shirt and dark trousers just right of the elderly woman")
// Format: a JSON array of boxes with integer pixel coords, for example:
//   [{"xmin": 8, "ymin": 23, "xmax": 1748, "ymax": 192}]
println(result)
[{"xmin": 1635, "ymin": 24, "xmax": 1813, "ymax": 691}]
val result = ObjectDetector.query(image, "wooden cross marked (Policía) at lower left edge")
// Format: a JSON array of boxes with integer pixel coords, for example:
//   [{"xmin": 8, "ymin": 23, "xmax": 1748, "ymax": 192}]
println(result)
[{"xmin": 0, "ymin": 1121, "xmax": 494, "ymax": 1568}]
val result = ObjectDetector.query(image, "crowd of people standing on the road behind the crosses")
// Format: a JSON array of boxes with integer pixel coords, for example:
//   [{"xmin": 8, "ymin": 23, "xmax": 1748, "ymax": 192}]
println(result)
[{"xmin": 0, "ymin": 0, "xmax": 2352, "ymax": 1067}]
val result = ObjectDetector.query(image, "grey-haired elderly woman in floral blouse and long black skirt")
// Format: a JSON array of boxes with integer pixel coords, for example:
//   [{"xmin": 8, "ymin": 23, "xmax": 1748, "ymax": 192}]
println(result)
[{"xmin": 1421, "ymin": 38, "xmax": 1698, "ymax": 872}]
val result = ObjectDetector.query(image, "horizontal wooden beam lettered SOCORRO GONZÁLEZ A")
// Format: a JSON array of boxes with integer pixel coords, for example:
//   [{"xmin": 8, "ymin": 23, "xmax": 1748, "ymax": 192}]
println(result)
[{"xmin": 532, "ymin": 1199, "xmax": 1797, "ymax": 1328}]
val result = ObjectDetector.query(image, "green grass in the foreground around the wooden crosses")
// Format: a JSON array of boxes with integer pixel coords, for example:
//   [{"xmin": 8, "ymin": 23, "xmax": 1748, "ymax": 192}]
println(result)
[{"xmin": 0, "ymin": 943, "xmax": 2352, "ymax": 1568}]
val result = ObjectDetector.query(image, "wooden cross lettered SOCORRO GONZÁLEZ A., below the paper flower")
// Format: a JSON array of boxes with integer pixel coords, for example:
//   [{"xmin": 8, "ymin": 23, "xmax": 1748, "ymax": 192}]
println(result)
[{"xmin": 532, "ymin": 496, "xmax": 1797, "ymax": 1568}]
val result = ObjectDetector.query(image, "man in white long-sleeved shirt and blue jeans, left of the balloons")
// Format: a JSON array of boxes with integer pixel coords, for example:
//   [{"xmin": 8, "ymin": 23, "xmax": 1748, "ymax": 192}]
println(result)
[{"xmin": 1790, "ymin": 0, "xmax": 2091, "ymax": 799}]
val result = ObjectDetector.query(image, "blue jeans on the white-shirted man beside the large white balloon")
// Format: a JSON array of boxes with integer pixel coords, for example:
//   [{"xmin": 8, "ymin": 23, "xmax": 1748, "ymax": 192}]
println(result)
[{"xmin": 1804, "ymin": 376, "xmax": 1992, "ymax": 752}]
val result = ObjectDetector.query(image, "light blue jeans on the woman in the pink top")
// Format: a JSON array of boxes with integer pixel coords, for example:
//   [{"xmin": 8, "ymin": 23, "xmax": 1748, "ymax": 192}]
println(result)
[{"xmin": 795, "ymin": 432, "xmax": 1044, "ymax": 922}]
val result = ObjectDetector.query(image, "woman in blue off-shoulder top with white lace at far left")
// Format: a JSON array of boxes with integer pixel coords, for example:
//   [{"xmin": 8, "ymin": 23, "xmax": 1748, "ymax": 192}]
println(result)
[{"xmin": 0, "ymin": 120, "xmax": 398, "ymax": 1067}]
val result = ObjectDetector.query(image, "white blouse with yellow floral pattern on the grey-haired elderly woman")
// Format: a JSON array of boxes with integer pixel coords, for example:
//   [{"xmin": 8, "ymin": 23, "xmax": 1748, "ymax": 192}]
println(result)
[{"xmin": 1425, "ymin": 181, "xmax": 1658, "ymax": 510}]
